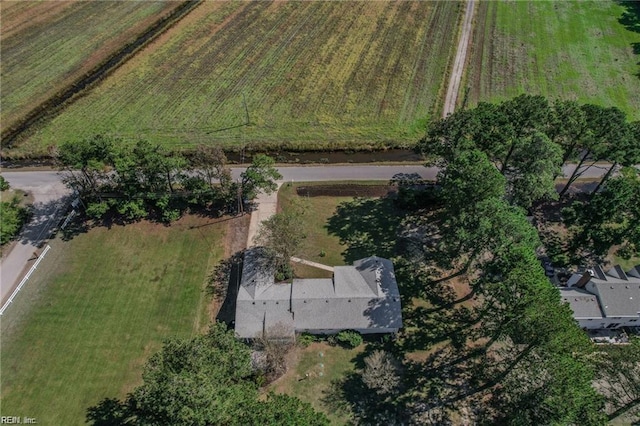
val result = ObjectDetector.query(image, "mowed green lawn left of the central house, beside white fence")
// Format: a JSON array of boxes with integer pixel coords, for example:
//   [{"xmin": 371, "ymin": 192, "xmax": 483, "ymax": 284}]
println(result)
[{"xmin": 1, "ymin": 217, "xmax": 227, "ymax": 425}]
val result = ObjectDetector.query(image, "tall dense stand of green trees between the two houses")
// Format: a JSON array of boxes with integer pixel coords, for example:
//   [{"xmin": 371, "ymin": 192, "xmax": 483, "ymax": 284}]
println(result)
[{"xmin": 404, "ymin": 138, "xmax": 605, "ymax": 425}]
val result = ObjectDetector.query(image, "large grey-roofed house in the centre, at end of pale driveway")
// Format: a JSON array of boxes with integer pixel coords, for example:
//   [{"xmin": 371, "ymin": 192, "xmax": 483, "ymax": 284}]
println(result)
[{"xmin": 235, "ymin": 247, "xmax": 402, "ymax": 338}]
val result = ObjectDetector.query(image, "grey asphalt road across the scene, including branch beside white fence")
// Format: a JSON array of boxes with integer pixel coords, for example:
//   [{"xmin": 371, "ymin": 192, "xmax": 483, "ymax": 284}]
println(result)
[{"xmin": 0, "ymin": 164, "xmax": 608, "ymax": 310}]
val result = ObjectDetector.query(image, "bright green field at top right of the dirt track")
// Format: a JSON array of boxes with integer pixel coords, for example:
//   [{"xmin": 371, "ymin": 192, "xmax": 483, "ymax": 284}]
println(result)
[{"xmin": 461, "ymin": 0, "xmax": 640, "ymax": 120}]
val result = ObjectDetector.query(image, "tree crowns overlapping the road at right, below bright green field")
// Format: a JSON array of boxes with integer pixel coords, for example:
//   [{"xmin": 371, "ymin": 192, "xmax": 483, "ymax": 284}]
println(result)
[{"xmin": 417, "ymin": 95, "xmax": 640, "ymax": 208}]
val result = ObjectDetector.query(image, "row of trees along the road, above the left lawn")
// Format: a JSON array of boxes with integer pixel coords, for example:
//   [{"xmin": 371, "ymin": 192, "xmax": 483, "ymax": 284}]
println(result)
[{"xmin": 55, "ymin": 135, "xmax": 281, "ymax": 222}]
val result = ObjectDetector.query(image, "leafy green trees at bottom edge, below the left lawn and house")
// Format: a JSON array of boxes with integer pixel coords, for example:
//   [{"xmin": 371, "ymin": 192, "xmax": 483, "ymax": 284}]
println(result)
[{"xmin": 87, "ymin": 323, "xmax": 328, "ymax": 426}]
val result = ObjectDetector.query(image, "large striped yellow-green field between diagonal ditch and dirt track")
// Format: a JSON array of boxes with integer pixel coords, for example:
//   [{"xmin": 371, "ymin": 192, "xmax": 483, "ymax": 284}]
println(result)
[{"xmin": 12, "ymin": 1, "xmax": 462, "ymax": 155}]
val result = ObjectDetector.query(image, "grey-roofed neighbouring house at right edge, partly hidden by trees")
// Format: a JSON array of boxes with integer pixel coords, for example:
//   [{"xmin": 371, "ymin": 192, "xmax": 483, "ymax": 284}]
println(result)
[{"xmin": 560, "ymin": 265, "xmax": 640, "ymax": 330}]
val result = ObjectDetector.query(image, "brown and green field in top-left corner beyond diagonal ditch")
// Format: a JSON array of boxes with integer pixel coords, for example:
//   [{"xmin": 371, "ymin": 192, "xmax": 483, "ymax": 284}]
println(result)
[{"xmin": 0, "ymin": 1, "xmax": 178, "ymax": 128}]
